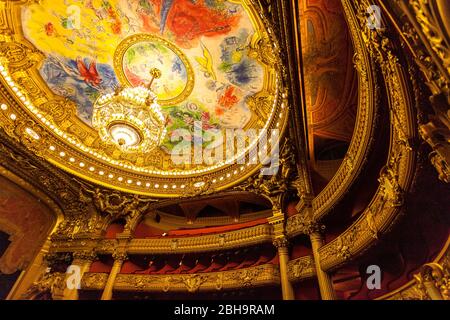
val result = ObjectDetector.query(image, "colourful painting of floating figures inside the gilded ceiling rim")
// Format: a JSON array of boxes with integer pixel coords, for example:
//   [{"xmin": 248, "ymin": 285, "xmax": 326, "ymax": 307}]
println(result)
[{"xmin": 22, "ymin": 0, "xmax": 264, "ymax": 151}]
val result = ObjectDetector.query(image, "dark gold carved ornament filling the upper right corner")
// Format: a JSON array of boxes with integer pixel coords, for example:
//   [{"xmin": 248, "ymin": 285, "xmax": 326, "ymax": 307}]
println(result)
[{"xmin": 377, "ymin": 0, "xmax": 450, "ymax": 183}]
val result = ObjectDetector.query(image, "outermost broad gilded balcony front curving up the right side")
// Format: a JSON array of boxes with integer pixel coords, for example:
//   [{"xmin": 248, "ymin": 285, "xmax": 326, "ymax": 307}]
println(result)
[{"xmin": 319, "ymin": 0, "xmax": 417, "ymax": 271}]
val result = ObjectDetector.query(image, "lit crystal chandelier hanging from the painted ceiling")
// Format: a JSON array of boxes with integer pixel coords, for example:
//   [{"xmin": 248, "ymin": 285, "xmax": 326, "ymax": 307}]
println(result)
[{"xmin": 92, "ymin": 68, "xmax": 166, "ymax": 152}]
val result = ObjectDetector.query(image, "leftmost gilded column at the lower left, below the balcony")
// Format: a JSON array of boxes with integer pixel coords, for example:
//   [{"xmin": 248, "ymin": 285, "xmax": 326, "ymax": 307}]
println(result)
[{"xmin": 63, "ymin": 250, "xmax": 97, "ymax": 300}]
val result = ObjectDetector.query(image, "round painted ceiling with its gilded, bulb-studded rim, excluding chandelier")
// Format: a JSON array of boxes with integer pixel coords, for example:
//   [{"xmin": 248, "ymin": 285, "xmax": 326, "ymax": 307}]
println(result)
[{"xmin": 0, "ymin": 0, "xmax": 287, "ymax": 196}]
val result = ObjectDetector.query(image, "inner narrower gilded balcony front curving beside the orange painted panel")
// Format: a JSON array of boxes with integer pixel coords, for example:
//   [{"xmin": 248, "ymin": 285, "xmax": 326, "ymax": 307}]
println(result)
[{"xmin": 286, "ymin": 0, "xmax": 379, "ymax": 236}]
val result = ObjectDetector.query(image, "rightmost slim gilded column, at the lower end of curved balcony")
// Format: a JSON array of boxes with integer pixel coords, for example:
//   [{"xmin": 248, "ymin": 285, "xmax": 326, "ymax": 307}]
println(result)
[{"xmin": 308, "ymin": 224, "xmax": 337, "ymax": 300}]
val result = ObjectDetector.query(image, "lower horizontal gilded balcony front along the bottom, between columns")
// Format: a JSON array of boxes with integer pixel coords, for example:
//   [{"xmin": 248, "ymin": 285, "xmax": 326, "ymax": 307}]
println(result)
[{"xmin": 81, "ymin": 264, "xmax": 280, "ymax": 293}]
